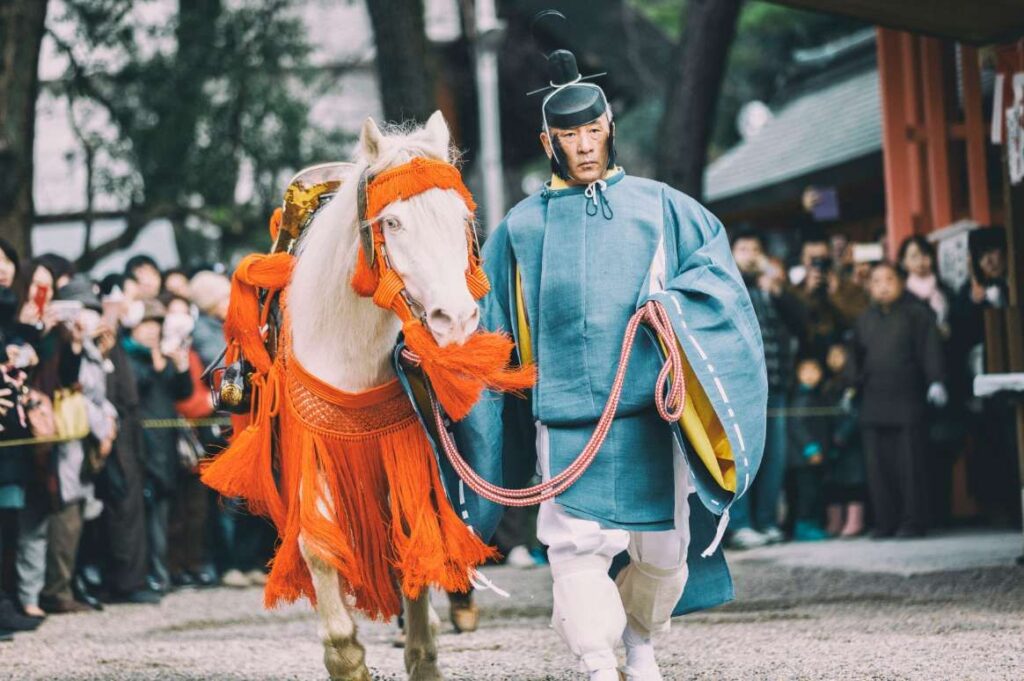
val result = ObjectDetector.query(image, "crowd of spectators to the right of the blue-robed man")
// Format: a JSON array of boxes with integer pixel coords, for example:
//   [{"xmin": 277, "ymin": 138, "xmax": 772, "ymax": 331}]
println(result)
[{"xmin": 729, "ymin": 227, "xmax": 1020, "ymax": 549}]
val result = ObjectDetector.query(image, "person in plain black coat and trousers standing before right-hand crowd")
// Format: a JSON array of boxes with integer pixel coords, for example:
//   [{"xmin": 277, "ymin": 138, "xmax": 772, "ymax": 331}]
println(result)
[{"xmin": 851, "ymin": 263, "xmax": 947, "ymax": 538}]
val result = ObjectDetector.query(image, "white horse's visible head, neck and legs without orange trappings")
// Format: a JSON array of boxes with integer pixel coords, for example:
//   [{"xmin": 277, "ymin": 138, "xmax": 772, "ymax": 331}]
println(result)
[{"xmin": 289, "ymin": 112, "xmax": 478, "ymax": 681}]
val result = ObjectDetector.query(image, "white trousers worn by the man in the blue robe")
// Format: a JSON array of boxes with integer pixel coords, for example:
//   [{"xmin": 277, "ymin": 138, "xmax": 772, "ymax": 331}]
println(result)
[{"xmin": 537, "ymin": 423, "xmax": 690, "ymax": 673}]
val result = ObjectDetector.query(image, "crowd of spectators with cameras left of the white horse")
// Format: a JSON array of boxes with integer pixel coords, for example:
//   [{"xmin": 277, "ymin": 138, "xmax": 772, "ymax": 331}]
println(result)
[{"xmin": 0, "ymin": 246, "xmax": 273, "ymax": 639}]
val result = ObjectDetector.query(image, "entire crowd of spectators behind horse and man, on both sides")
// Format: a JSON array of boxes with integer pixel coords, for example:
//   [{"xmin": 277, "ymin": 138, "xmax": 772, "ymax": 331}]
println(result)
[{"xmin": 0, "ymin": 220, "xmax": 1020, "ymax": 640}]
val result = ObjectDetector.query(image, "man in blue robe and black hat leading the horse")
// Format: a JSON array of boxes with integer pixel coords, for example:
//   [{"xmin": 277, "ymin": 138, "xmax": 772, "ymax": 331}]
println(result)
[{"xmin": 445, "ymin": 50, "xmax": 767, "ymax": 681}]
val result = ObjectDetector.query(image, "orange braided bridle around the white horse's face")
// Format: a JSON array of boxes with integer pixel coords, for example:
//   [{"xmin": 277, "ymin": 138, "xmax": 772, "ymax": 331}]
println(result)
[{"xmin": 351, "ymin": 157, "xmax": 490, "ymax": 324}]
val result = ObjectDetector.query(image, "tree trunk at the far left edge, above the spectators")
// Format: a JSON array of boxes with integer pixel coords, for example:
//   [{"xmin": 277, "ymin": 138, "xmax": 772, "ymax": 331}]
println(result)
[{"xmin": 0, "ymin": 0, "xmax": 46, "ymax": 257}]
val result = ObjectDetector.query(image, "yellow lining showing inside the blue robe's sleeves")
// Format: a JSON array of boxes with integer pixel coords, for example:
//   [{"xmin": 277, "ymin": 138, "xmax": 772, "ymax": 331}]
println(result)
[{"xmin": 515, "ymin": 265, "xmax": 736, "ymax": 493}]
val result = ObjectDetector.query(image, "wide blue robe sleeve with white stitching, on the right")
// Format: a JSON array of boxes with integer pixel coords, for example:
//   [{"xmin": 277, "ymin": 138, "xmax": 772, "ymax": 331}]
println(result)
[{"xmin": 651, "ymin": 188, "xmax": 768, "ymax": 515}]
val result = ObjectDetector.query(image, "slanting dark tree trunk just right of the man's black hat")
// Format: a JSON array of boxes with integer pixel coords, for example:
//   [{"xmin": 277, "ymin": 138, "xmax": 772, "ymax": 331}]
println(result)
[{"xmin": 657, "ymin": 0, "xmax": 742, "ymax": 201}]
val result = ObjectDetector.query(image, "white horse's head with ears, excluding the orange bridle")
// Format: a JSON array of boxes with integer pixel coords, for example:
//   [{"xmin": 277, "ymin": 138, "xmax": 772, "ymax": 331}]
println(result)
[{"xmin": 359, "ymin": 112, "xmax": 479, "ymax": 346}]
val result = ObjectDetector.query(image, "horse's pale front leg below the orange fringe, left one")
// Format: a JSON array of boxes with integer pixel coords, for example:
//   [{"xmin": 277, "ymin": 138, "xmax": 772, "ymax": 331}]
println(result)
[{"xmin": 299, "ymin": 541, "xmax": 372, "ymax": 681}]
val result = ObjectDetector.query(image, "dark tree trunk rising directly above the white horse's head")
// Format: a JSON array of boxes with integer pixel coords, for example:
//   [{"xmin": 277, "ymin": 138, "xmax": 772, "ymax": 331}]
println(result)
[{"xmin": 367, "ymin": 0, "xmax": 435, "ymax": 123}]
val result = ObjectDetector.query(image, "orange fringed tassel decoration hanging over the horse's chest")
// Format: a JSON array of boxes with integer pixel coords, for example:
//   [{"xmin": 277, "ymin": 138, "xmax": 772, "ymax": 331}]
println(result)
[{"xmin": 203, "ymin": 311, "xmax": 497, "ymax": 619}]
